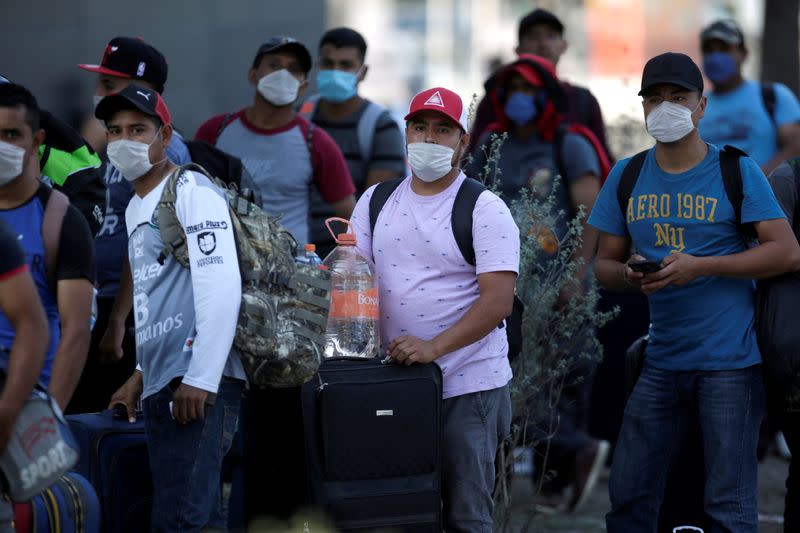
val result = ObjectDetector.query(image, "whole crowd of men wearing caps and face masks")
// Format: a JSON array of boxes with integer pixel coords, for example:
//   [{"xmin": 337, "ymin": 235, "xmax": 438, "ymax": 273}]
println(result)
[{"xmin": 0, "ymin": 5, "xmax": 800, "ymax": 533}]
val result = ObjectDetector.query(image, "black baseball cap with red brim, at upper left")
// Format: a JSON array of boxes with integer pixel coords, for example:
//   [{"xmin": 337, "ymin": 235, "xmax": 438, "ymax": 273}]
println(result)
[{"xmin": 78, "ymin": 37, "xmax": 168, "ymax": 93}]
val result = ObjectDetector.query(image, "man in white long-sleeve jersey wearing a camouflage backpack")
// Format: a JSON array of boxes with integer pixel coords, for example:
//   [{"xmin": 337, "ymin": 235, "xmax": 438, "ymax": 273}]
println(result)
[{"xmin": 102, "ymin": 85, "xmax": 246, "ymax": 532}]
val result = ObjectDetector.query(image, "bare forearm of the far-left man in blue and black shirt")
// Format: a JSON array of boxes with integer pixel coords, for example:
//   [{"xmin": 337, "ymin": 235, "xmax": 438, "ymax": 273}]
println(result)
[{"xmin": 49, "ymin": 324, "xmax": 91, "ymax": 409}]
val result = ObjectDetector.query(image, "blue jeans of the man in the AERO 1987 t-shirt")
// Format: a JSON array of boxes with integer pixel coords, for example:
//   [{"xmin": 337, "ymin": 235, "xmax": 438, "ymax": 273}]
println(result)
[{"xmin": 606, "ymin": 365, "xmax": 765, "ymax": 533}]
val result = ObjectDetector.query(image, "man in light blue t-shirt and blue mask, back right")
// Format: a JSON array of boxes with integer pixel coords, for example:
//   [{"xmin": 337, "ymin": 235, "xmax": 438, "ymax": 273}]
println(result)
[{"xmin": 699, "ymin": 19, "xmax": 800, "ymax": 174}]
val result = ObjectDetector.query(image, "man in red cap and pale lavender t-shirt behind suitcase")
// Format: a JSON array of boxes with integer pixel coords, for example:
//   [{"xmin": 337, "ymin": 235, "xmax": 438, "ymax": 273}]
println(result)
[{"xmin": 351, "ymin": 87, "xmax": 519, "ymax": 531}]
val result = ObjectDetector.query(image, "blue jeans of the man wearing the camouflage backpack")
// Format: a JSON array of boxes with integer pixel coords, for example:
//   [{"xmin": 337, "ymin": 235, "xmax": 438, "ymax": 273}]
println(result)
[{"xmin": 143, "ymin": 378, "xmax": 244, "ymax": 533}]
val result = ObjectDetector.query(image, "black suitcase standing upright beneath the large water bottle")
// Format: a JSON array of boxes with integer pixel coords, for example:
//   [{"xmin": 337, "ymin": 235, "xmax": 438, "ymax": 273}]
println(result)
[{"xmin": 303, "ymin": 359, "xmax": 442, "ymax": 533}]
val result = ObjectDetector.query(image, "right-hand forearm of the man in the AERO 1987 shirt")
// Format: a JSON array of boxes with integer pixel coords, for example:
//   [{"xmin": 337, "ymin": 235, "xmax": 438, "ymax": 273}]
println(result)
[{"xmin": 700, "ymin": 242, "xmax": 796, "ymax": 279}]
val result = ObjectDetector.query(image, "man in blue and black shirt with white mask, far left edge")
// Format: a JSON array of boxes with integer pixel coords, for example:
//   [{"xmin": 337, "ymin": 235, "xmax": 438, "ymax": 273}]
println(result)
[{"xmin": 0, "ymin": 83, "xmax": 95, "ymax": 408}]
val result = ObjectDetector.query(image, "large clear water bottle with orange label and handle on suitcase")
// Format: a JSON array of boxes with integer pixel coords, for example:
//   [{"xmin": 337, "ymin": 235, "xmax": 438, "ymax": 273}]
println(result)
[{"xmin": 323, "ymin": 218, "xmax": 380, "ymax": 359}]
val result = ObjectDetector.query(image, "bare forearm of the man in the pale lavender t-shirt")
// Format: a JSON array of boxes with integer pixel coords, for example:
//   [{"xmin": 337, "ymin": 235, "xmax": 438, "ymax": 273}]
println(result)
[{"xmin": 431, "ymin": 295, "xmax": 514, "ymax": 357}]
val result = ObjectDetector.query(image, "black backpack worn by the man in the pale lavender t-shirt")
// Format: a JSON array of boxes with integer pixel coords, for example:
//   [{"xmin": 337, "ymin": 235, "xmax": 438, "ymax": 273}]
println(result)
[{"xmin": 369, "ymin": 178, "xmax": 525, "ymax": 359}]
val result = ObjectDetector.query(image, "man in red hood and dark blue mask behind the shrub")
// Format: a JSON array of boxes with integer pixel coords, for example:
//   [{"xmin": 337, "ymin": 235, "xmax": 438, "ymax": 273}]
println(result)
[{"xmin": 467, "ymin": 54, "xmax": 609, "ymax": 509}]
